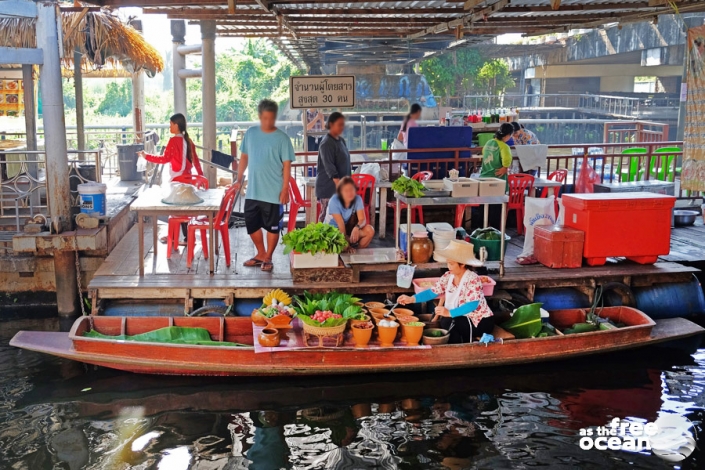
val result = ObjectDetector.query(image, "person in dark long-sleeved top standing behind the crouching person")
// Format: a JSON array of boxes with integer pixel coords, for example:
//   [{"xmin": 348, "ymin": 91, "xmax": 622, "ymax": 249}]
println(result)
[{"xmin": 316, "ymin": 112, "xmax": 352, "ymax": 222}]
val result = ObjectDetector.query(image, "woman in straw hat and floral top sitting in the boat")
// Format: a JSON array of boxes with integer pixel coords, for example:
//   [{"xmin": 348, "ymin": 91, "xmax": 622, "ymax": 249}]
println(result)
[{"xmin": 398, "ymin": 240, "xmax": 494, "ymax": 344}]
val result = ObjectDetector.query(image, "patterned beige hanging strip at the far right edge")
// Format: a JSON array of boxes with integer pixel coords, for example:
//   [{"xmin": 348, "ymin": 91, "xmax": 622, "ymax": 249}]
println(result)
[{"xmin": 681, "ymin": 26, "xmax": 705, "ymax": 191}]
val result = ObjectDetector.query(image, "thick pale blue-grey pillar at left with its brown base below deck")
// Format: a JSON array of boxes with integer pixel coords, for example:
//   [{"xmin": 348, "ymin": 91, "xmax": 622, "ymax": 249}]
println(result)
[{"xmin": 36, "ymin": 2, "xmax": 79, "ymax": 316}]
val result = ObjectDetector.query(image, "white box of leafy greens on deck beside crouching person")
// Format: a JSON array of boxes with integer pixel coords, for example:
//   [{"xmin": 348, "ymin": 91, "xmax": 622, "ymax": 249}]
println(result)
[{"xmin": 282, "ymin": 222, "xmax": 348, "ymax": 269}]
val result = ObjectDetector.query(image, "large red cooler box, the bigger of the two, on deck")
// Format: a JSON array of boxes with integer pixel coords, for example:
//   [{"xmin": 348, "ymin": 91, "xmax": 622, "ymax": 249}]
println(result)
[{"xmin": 563, "ymin": 192, "xmax": 676, "ymax": 266}]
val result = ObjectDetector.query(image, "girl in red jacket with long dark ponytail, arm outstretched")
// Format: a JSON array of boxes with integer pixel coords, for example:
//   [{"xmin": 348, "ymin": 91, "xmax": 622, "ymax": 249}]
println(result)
[{"xmin": 139, "ymin": 113, "xmax": 203, "ymax": 182}]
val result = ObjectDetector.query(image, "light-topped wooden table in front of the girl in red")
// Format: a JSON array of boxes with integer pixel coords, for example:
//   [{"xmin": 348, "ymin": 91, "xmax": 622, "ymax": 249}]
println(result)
[{"xmin": 130, "ymin": 187, "xmax": 225, "ymax": 277}]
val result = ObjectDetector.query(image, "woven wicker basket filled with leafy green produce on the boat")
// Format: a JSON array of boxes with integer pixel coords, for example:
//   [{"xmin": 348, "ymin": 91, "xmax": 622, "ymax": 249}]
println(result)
[{"xmin": 294, "ymin": 292, "xmax": 369, "ymax": 347}]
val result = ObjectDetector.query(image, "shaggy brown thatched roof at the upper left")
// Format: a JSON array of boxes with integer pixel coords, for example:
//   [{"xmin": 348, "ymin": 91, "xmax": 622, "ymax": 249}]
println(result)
[{"xmin": 0, "ymin": 12, "xmax": 164, "ymax": 75}]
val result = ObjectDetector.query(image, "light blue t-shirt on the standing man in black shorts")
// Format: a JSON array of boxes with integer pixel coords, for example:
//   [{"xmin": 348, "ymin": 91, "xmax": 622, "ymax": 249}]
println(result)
[{"xmin": 241, "ymin": 126, "xmax": 296, "ymax": 204}]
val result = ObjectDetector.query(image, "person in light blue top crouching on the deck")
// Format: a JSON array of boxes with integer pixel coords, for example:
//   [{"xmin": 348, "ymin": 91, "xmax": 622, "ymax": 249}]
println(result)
[{"xmin": 325, "ymin": 176, "xmax": 375, "ymax": 251}]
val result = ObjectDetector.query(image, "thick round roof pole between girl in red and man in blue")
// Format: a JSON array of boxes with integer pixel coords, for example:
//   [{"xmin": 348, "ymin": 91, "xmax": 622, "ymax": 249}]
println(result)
[{"xmin": 201, "ymin": 20, "xmax": 217, "ymax": 187}]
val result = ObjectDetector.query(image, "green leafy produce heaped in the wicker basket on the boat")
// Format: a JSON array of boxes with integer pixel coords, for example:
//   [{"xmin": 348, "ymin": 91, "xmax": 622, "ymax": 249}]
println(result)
[{"xmin": 294, "ymin": 292, "xmax": 364, "ymax": 327}]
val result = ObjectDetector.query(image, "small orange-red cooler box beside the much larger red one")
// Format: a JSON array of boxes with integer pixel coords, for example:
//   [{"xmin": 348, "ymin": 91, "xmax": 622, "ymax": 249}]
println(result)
[{"xmin": 534, "ymin": 225, "xmax": 585, "ymax": 268}]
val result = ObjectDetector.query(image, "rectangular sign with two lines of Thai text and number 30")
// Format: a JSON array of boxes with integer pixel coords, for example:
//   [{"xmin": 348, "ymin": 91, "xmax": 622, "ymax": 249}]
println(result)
[{"xmin": 289, "ymin": 75, "xmax": 355, "ymax": 109}]
